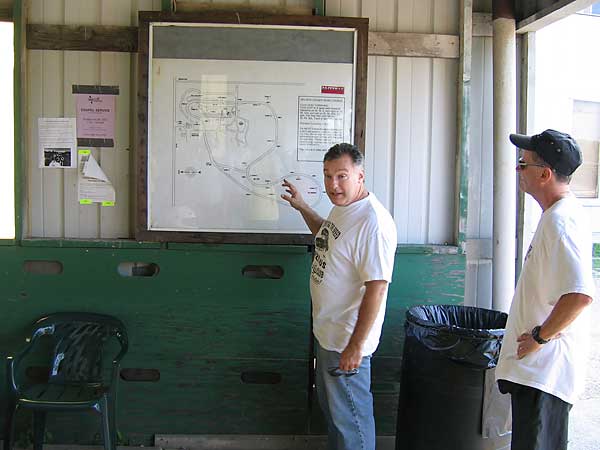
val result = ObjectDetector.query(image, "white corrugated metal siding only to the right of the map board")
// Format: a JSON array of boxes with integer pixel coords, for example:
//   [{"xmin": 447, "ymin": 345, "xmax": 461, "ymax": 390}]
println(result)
[{"xmin": 327, "ymin": 0, "xmax": 459, "ymax": 244}]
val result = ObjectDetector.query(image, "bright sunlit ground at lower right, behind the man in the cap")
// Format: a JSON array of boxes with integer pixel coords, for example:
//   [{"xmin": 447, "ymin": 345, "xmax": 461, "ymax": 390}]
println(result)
[{"xmin": 569, "ymin": 278, "xmax": 600, "ymax": 450}]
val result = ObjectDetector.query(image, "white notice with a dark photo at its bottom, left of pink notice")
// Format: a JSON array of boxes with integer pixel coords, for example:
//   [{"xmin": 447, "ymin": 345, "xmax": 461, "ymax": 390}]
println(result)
[{"xmin": 38, "ymin": 117, "xmax": 77, "ymax": 169}]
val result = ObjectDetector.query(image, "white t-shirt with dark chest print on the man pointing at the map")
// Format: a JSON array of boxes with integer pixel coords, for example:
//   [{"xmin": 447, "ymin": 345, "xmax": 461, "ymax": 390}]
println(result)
[{"xmin": 310, "ymin": 193, "xmax": 397, "ymax": 356}]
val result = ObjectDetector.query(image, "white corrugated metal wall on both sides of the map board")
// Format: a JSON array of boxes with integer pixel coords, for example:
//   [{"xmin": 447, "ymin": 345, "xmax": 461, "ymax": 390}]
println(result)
[{"xmin": 24, "ymin": 0, "xmax": 458, "ymax": 244}]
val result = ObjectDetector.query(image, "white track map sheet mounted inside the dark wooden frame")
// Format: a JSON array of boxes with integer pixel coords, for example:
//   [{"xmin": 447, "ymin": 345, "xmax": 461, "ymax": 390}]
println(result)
[{"xmin": 147, "ymin": 24, "xmax": 364, "ymax": 239}]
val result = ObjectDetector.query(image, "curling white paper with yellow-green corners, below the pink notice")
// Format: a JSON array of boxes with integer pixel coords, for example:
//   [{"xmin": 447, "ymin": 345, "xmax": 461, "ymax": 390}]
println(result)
[{"xmin": 77, "ymin": 150, "xmax": 115, "ymax": 206}]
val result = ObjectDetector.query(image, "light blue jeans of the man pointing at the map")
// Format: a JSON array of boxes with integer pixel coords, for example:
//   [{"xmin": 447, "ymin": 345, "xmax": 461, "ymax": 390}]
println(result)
[{"xmin": 315, "ymin": 342, "xmax": 375, "ymax": 450}]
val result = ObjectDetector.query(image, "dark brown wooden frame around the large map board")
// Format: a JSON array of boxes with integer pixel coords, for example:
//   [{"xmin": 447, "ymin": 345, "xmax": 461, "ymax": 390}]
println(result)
[{"xmin": 134, "ymin": 12, "xmax": 368, "ymax": 245}]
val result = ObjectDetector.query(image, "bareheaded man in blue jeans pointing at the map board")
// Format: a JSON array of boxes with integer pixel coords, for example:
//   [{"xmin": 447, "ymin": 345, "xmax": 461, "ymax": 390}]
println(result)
[{"xmin": 282, "ymin": 144, "xmax": 397, "ymax": 450}]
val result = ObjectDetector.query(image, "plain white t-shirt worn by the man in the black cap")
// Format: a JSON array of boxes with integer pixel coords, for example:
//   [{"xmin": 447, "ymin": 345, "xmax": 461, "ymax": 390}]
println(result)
[{"xmin": 496, "ymin": 196, "xmax": 595, "ymax": 404}]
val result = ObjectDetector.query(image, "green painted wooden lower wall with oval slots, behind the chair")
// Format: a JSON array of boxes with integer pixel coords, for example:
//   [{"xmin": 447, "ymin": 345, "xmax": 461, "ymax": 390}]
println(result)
[{"xmin": 0, "ymin": 241, "xmax": 465, "ymax": 445}]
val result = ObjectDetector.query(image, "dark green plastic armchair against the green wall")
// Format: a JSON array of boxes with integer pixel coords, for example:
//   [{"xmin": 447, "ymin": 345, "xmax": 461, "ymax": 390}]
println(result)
[{"xmin": 4, "ymin": 313, "xmax": 128, "ymax": 450}]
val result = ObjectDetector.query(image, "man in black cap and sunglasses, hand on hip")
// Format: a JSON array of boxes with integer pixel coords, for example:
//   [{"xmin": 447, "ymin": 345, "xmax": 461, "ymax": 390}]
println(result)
[{"xmin": 496, "ymin": 130, "xmax": 595, "ymax": 450}]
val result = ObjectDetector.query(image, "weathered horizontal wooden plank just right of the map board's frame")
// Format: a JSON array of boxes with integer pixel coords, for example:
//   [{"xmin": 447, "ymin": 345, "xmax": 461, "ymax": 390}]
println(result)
[{"xmin": 369, "ymin": 31, "xmax": 460, "ymax": 58}]
